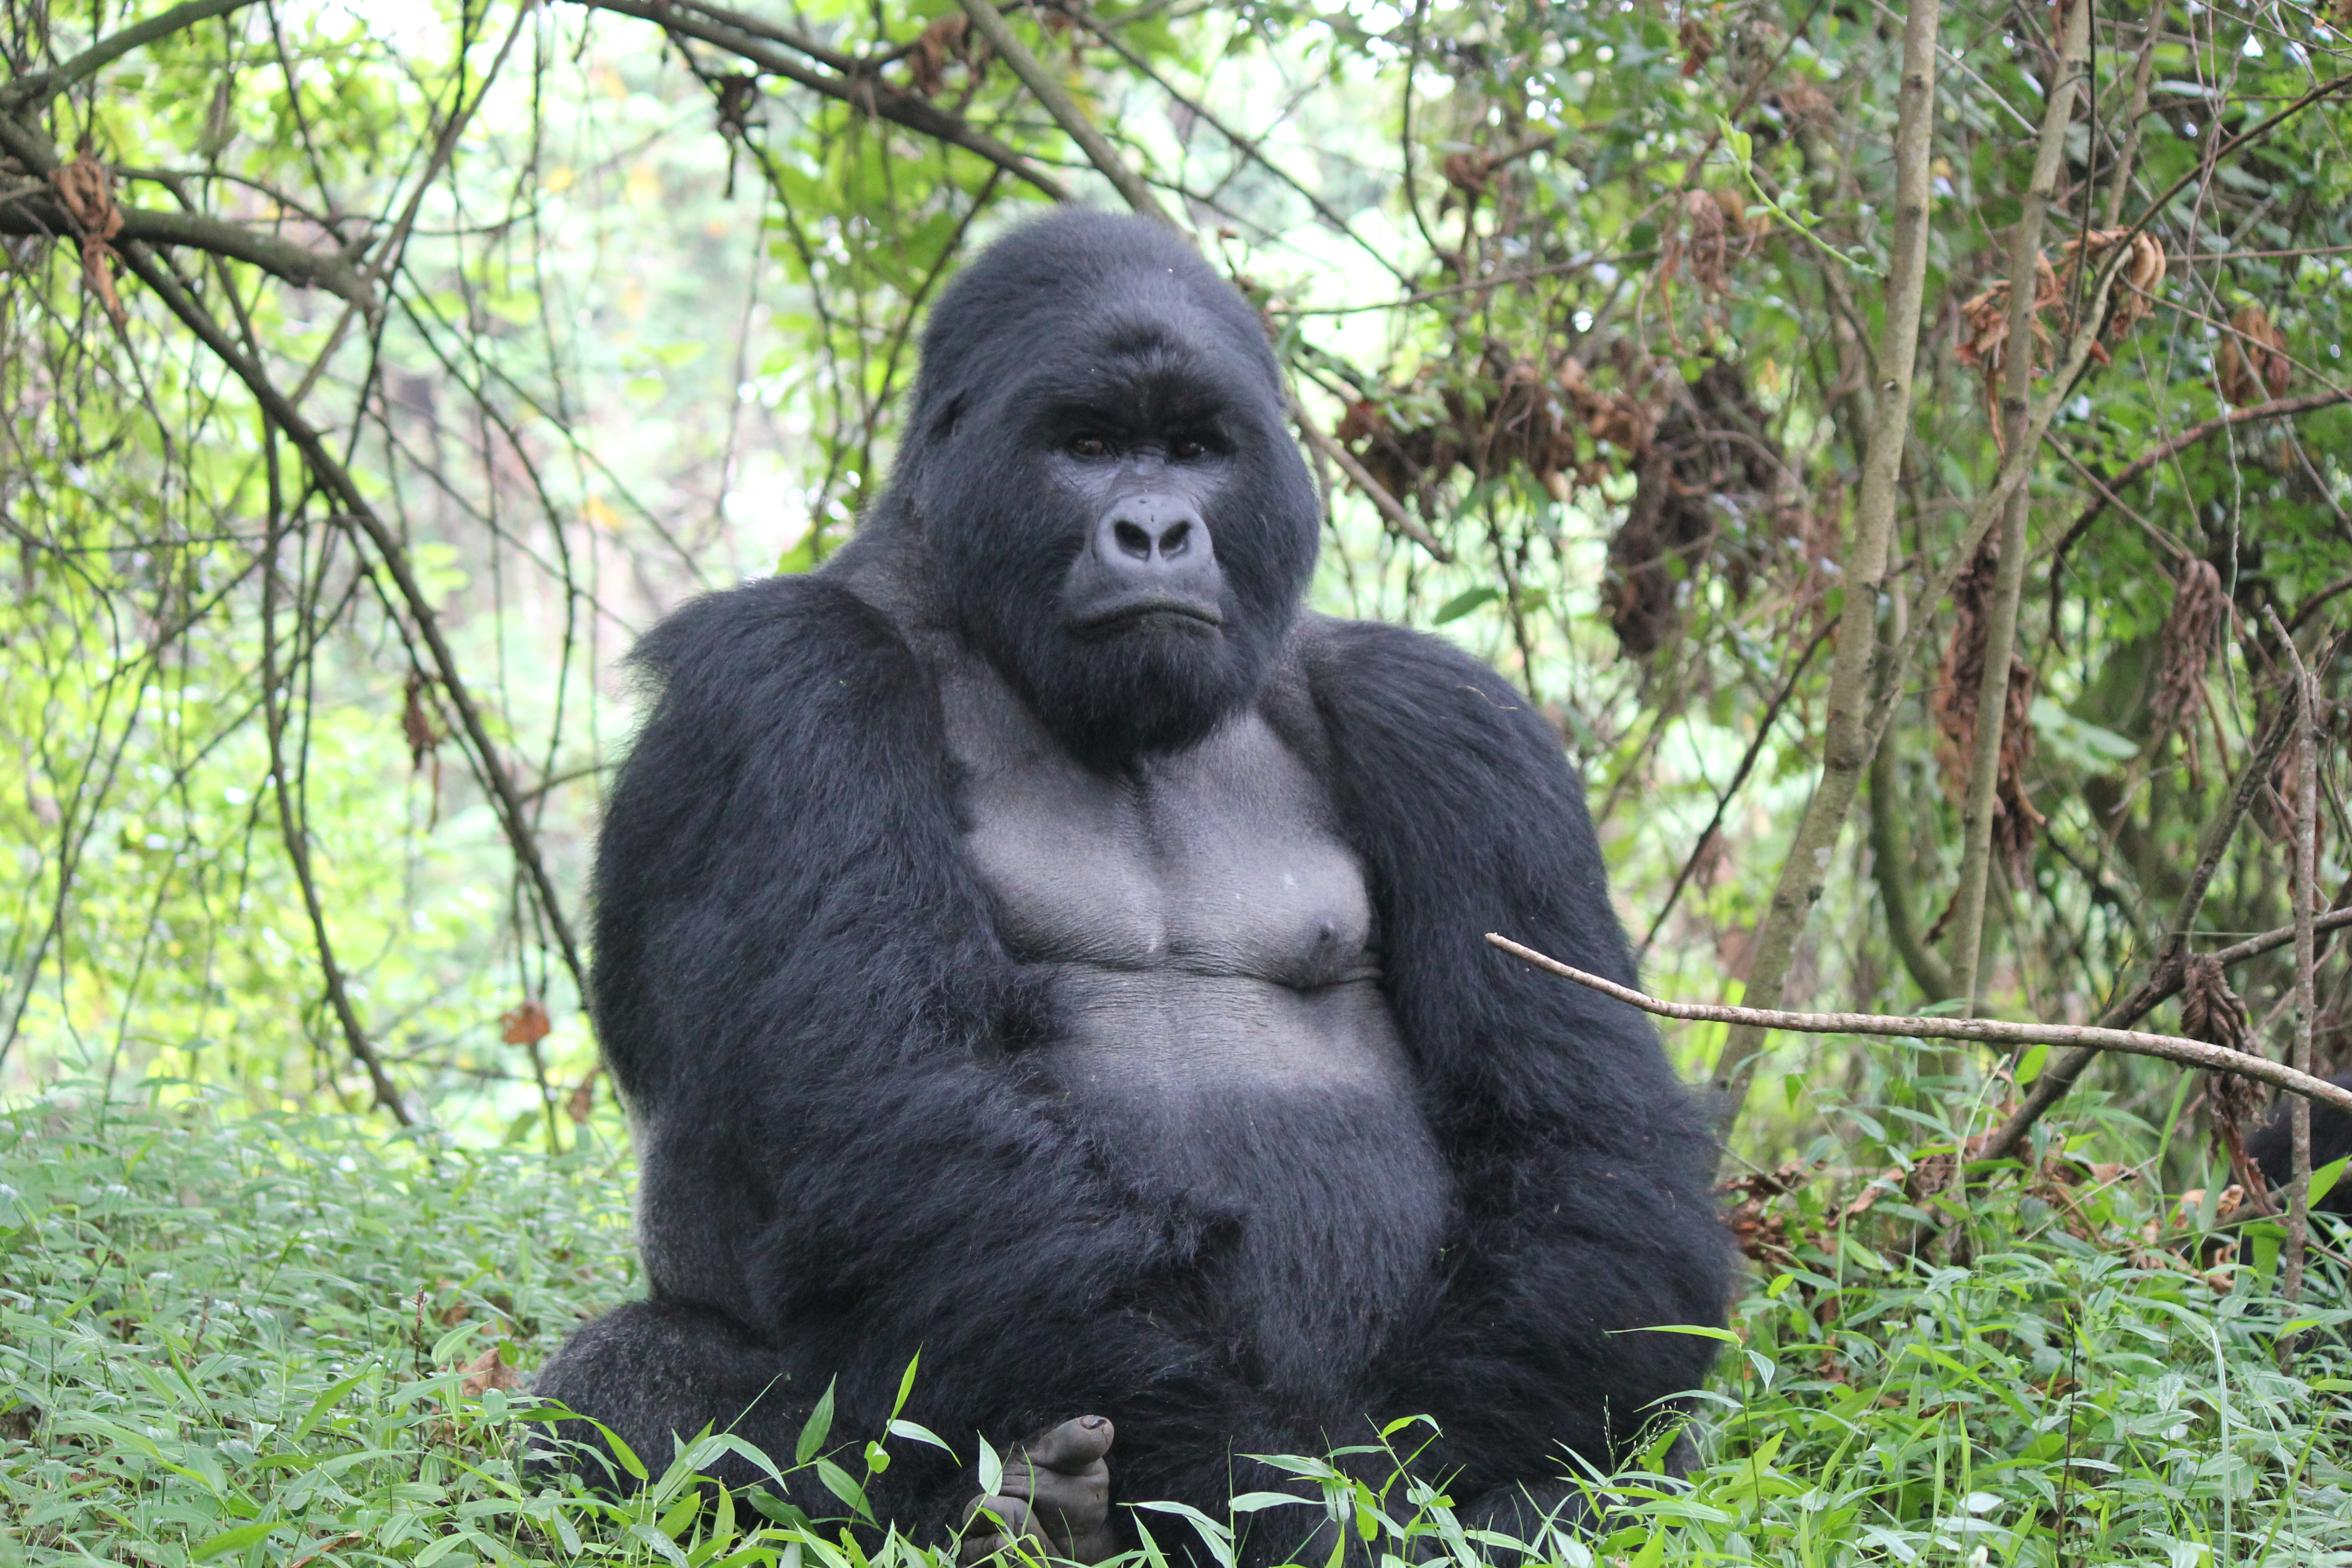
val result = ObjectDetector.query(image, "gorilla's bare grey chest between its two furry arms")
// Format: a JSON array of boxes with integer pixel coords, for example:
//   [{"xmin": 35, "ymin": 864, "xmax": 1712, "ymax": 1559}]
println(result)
[{"xmin": 948, "ymin": 677, "xmax": 1404, "ymax": 1102}]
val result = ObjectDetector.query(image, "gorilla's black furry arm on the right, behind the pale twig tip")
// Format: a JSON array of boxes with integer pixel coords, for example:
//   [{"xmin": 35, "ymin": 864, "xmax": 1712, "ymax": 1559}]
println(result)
[{"xmin": 1305, "ymin": 621, "xmax": 1731, "ymax": 1500}]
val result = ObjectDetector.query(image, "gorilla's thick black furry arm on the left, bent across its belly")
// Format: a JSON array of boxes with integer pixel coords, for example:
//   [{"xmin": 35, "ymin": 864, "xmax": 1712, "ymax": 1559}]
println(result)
[{"xmin": 583, "ymin": 578, "xmax": 1223, "ymax": 1481}]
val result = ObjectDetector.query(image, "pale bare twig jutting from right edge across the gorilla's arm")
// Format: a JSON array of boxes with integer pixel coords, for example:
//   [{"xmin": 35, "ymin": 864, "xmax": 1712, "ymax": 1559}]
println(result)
[{"xmin": 1486, "ymin": 931, "xmax": 2352, "ymax": 1123}]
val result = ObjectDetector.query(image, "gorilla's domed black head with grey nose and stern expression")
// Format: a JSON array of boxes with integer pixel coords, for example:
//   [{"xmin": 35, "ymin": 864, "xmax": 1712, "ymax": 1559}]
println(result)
[{"xmin": 894, "ymin": 211, "xmax": 1317, "ymax": 764}]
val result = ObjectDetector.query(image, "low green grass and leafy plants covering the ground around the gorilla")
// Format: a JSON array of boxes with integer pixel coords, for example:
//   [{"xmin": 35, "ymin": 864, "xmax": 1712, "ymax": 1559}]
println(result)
[{"xmin": 0, "ymin": 1091, "xmax": 2352, "ymax": 1568}]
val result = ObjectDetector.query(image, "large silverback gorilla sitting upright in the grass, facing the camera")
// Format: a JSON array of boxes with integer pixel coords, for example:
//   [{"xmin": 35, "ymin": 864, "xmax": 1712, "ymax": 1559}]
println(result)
[{"xmin": 539, "ymin": 214, "xmax": 1731, "ymax": 1561}]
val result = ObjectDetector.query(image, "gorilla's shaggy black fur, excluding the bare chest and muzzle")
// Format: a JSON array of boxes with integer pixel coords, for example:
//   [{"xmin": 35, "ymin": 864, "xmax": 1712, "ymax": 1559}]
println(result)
[{"xmin": 539, "ymin": 216, "xmax": 1731, "ymax": 1558}]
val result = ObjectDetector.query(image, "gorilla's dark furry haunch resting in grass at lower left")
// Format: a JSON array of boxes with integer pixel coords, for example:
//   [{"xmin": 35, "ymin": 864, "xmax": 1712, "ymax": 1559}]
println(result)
[{"xmin": 532, "ymin": 1300, "xmax": 809, "ymax": 1490}]
